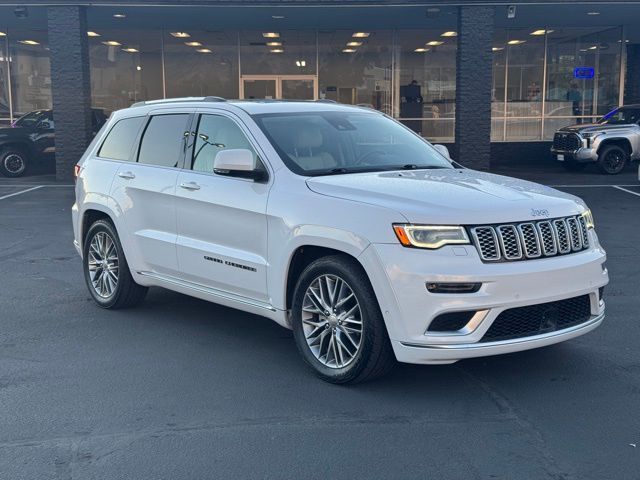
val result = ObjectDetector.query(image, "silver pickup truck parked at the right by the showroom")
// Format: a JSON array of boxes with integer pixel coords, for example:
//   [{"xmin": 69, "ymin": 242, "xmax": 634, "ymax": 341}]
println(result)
[{"xmin": 551, "ymin": 105, "xmax": 640, "ymax": 174}]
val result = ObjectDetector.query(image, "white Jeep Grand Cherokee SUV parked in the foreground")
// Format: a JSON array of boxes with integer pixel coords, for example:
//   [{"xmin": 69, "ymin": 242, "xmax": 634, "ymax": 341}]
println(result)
[{"xmin": 73, "ymin": 97, "xmax": 608, "ymax": 383}]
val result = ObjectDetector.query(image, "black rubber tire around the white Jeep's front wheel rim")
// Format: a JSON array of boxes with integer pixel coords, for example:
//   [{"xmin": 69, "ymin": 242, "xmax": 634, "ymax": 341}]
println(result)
[{"xmin": 291, "ymin": 255, "xmax": 396, "ymax": 384}]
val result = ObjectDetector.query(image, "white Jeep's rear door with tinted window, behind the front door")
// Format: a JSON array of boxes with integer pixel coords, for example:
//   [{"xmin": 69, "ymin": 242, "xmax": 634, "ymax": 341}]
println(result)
[{"xmin": 111, "ymin": 109, "xmax": 192, "ymax": 276}]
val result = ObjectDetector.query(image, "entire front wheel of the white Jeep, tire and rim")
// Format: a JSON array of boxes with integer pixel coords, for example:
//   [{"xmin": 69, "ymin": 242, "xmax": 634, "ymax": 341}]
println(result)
[{"xmin": 291, "ymin": 255, "xmax": 395, "ymax": 383}]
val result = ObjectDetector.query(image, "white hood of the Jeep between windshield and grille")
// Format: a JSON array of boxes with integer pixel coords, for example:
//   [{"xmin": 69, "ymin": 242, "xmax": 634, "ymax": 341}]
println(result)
[{"xmin": 307, "ymin": 169, "xmax": 586, "ymax": 225}]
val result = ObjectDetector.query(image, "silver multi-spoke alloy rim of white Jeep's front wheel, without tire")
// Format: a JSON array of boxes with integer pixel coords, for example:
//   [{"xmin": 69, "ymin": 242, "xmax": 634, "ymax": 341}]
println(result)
[{"xmin": 302, "ymin": 275, "xmax": 362, "ymax": 368}]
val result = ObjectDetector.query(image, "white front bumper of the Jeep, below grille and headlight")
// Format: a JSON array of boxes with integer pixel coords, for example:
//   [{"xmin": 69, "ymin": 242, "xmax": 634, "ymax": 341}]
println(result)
[{"xmin": 360, "ymin": 238, "xmax": 609, "ymax": 363}]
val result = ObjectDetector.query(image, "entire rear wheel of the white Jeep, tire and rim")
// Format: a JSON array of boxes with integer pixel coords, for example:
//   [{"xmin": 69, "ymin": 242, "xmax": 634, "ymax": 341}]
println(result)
[{"xmin": 83, "ymin": 220, "xmax": 147, "ymax": 309}]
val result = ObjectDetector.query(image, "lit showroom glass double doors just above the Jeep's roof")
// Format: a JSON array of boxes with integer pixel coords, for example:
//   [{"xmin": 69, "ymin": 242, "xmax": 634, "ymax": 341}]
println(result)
[{"xmin": 240, "ymin": 75, "xmax": 318, "ymax": 100}]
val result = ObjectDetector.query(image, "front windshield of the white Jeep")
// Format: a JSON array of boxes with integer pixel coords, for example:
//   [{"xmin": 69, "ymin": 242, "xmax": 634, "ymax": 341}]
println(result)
[{"xmin": 253, "ymin": 112, "xmax": 453, "ymax": 176}]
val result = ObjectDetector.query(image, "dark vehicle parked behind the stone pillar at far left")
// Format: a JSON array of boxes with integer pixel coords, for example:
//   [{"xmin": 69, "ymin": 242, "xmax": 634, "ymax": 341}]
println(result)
[{"xmin": 0, "ymin": 109, "xmax": 107, "ymax": 177}]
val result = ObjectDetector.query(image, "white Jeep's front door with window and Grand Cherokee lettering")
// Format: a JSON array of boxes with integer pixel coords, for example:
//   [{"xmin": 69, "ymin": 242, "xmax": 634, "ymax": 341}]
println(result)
[{"xmin": 176, "ymin": 111, "xmax": 271, "ymax": 302}]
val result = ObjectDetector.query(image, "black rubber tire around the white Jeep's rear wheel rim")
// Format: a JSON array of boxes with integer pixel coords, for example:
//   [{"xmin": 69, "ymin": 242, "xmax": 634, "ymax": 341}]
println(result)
[{"xmin": 82, "ymin": 220, "xmax": 148, "ymax": 309}]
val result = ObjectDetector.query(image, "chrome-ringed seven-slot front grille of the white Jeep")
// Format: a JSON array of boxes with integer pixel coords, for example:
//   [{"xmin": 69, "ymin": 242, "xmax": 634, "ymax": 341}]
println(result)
[{"xmin": 470, "ymin": 215, "xmax": 589, "ymax": 262}]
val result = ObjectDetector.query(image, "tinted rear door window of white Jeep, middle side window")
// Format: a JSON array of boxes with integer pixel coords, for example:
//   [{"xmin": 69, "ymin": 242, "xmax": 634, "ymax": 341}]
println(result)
[{"xmin": 138, "ymin": 113, "xmax": 189, "ymax": 167}]
